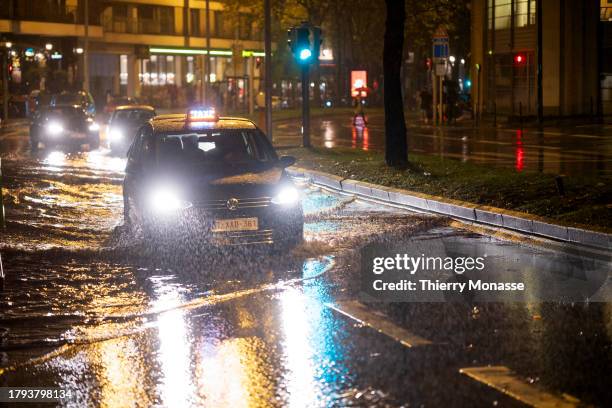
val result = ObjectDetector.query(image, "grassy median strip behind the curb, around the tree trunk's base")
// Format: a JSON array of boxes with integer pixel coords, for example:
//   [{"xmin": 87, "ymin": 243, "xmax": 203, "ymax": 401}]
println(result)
[{"xmin": 280, "ymin": 148, "xmax": 612, "ymax": 233}]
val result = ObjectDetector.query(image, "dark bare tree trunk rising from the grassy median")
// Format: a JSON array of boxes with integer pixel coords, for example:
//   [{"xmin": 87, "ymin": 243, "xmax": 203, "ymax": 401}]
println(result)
[{"xmin": 383, "ymin": 0, "xmax": 408, "ymax": 167}]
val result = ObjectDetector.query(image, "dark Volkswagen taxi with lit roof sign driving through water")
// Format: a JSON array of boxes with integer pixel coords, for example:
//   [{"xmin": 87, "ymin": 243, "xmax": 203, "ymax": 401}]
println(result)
[{"xmin": 123, "ymin": 109, "xmax": 303, "ymax": 248}]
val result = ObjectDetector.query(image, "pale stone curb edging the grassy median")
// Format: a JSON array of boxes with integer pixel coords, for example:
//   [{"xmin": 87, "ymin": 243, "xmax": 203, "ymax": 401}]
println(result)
[{"xmin": 287, "ymin": 167, "xmax": 612, "ymax": 250}]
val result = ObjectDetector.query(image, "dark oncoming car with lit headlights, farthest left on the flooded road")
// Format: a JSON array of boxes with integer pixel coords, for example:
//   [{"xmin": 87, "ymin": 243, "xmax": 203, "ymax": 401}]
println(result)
[{"xmin": 30, "ymin": 105, "xmax": 100, "ymax": 151}]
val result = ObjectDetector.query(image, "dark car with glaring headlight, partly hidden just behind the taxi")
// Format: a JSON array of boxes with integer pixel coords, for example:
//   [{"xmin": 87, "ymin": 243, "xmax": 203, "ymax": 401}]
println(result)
[{"xmin": 106, "ymin": 105, "xmax": 155, "ymax": 155}]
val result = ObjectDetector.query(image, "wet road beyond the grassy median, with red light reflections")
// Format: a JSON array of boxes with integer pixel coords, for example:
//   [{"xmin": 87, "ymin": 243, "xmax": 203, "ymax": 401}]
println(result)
[{"xmin": 274, "ymin": 112, "xmax": 612, "ymax": 175}]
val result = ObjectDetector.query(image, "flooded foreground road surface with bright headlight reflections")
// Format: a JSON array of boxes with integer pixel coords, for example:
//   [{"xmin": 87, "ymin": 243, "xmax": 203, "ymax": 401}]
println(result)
[{"xmin": 0, "ymin": 122, "xmax": 612, "ymax": 407}]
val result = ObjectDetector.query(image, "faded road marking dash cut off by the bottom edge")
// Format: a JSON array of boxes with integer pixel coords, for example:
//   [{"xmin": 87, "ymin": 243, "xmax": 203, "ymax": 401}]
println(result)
[{"xmin": 459, "ymin": 366, "xmax": 580, "ymax": 408}]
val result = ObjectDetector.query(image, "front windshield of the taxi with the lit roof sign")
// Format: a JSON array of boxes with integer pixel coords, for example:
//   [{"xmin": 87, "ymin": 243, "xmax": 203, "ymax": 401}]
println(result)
[{"xmin": 157, "ymin": 130, "xmax": 276, "ymax": 166}]
